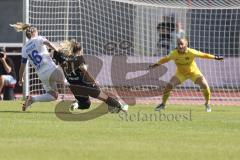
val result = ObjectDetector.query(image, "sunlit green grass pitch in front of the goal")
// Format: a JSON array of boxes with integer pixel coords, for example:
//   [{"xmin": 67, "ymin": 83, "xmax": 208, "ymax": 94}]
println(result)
[{"xmin": 0, "ymin": 101, "xmax": 240, "ymax": 160}]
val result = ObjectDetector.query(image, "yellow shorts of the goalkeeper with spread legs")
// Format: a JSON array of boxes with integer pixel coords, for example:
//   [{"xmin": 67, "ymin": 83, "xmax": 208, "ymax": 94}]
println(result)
[{"xmin": 175, "ymin": 71, "xmax": 203, "ymax": 83}]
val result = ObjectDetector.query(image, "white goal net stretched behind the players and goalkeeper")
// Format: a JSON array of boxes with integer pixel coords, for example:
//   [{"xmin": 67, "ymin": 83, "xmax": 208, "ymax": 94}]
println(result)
[{"xmin": 27, "ymin": 0, "xmax": 240, "ymax": 104}]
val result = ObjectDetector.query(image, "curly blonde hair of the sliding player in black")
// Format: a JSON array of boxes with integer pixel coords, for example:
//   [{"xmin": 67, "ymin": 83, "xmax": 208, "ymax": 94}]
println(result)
[{"xmin": 59, "ymin": 39, "xmax": 82, "ymax": 56}]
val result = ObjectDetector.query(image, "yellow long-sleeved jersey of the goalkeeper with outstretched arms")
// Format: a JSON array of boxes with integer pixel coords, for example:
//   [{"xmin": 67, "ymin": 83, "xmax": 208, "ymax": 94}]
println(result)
[{"xmin": 160, "ymin": 48, "xmax": 215, "ymax": 75}]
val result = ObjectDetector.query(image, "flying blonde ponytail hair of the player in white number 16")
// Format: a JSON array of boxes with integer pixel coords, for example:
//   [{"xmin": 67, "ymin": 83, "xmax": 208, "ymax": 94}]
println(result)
[{"xmin": 10, "ymin": 22, "xmax": 37, "ymax": 39}]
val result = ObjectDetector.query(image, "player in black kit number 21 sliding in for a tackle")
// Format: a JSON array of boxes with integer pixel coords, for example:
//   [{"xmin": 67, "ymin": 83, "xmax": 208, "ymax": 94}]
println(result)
[{"xmin": 53, "ymin": 40, "xmax": 128, "ymax": 112}]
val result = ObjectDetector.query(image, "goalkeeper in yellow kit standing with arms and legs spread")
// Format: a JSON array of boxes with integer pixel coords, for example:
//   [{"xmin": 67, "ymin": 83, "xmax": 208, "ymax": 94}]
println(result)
[{"xmin": 149, "ymin": 38, "xmax": 223, "ymax": 112}]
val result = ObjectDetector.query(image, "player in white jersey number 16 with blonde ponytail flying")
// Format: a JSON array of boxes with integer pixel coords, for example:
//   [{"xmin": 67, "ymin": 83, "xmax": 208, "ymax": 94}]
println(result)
[{"xmin": 11, "ymin": 23, "xmax": 65, "ymax": 111}]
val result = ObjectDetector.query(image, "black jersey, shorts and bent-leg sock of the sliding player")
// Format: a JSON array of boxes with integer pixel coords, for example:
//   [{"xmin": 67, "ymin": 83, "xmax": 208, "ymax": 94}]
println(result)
[{"xmin": 53, "ymin": 52, "xmax": 100, "ymax": 109}]
